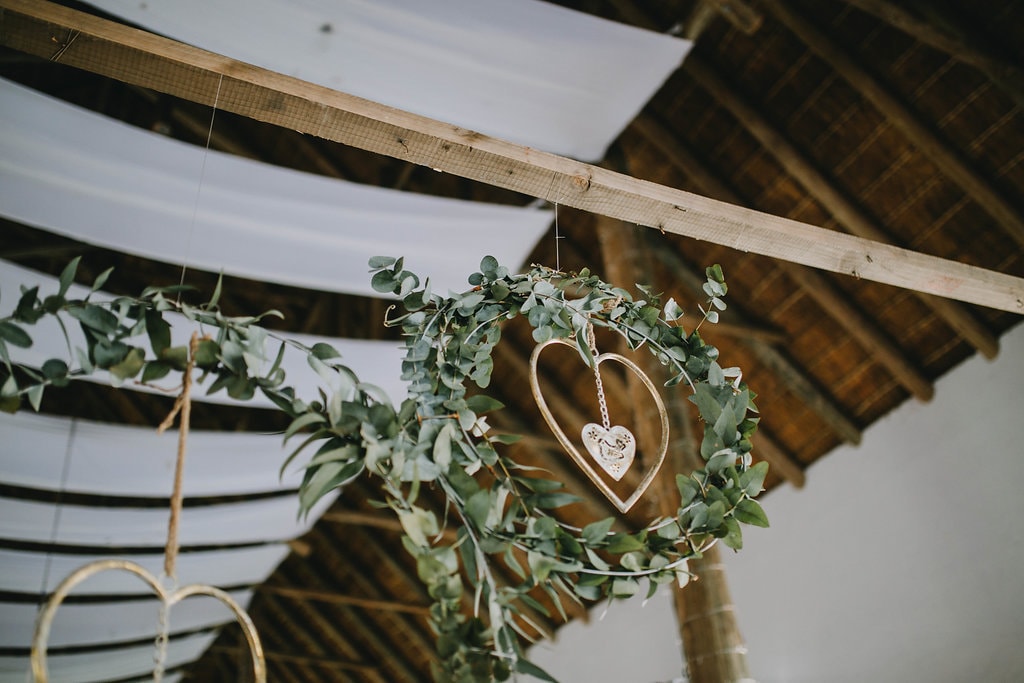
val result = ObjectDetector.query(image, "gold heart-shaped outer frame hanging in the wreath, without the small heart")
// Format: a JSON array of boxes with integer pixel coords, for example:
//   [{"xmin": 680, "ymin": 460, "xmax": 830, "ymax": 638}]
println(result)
[{"xmin": 529, "ymin": 339, "xmax": 669, "ymax": 512}]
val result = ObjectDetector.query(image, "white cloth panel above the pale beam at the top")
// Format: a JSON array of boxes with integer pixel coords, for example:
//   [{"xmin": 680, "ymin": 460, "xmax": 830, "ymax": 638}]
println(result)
[{"xmin": 83, "ymin": 0, "xmax": 691, "ymax": 161}]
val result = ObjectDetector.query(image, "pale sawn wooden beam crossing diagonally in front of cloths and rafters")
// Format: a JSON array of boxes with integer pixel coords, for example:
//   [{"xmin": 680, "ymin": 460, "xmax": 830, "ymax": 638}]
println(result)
[{"xmin": 0, "ymin": 0, "xmax": 1024, "ymax": 313}]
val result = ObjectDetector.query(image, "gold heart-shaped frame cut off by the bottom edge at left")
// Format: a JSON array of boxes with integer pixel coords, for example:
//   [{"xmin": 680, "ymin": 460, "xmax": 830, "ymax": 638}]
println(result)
[{"xmin": 32, "ymin": 559, "xmax": 266, "ymax": 683}]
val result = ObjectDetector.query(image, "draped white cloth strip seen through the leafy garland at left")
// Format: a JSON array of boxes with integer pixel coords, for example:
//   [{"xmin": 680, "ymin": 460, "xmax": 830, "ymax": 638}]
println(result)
[{"xmin": 0, "ymin": 255, "xmax": 406, "ymax": 408}]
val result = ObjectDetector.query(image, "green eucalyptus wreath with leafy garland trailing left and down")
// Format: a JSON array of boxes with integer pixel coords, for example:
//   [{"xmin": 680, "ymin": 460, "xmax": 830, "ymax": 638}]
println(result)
[{"xmin": 0, "ymin": 256, "xmax": 768, "ymax": 682}]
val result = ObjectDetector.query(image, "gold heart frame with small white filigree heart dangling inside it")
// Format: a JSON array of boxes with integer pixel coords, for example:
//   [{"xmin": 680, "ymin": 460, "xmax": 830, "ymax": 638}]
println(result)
[{"xmin": 529, "ymin": 339, "xmax": 669, "ymax": 512}]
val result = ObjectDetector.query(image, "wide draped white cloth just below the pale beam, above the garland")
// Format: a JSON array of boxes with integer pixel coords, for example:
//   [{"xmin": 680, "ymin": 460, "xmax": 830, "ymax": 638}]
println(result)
[{"xmin": 0, "ymin": 77, "xmax": 552, "ymax": 297}]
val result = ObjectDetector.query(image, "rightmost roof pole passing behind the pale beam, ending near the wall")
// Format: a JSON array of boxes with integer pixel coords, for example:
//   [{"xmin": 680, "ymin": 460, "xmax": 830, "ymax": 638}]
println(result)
[{"xmin": 685, "ymin": 57, "xmax": 999, "ymax": 358}]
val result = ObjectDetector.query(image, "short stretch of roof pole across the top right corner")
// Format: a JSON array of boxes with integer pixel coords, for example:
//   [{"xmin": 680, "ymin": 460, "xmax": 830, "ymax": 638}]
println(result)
[{"xmin": 846, "ymin": 0, "xmax": 1024, "ymax": 108}]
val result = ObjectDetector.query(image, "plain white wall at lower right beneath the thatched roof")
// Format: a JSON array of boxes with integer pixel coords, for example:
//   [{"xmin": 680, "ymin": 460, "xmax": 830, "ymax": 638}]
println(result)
[{"xmin": 531, "ymin": 325, "xmax": 1024, "ymax": 683}]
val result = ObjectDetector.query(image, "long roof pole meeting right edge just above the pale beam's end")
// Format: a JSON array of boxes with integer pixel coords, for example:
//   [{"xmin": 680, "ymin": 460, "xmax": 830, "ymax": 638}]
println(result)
[{"xmin": 767, "ymin": 2, "xmax": 1024, "ymax": 253}]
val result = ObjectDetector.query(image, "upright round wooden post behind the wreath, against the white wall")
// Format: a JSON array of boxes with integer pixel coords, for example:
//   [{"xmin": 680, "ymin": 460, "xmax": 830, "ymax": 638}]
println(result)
[{"xmin": 597, "ymin": 218, "xmax": 751, "ymax": 683}]
